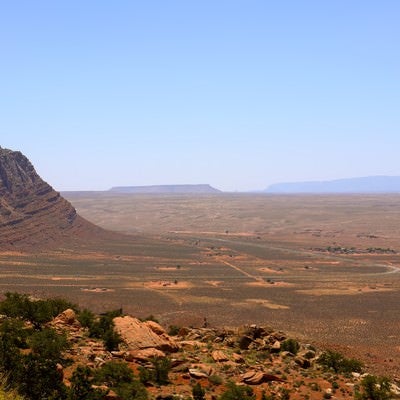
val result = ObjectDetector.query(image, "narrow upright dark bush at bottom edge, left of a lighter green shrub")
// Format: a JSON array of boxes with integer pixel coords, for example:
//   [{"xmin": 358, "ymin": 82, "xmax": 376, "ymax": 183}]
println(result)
[{"xmin": 68, "ymin": 366, "xmax": 106, "ymax": 400}]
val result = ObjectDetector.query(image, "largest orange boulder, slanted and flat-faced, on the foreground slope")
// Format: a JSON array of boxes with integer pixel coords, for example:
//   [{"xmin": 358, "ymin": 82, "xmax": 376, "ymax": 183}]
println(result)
[{"xmin": 114, "ymin": 316, "xmax": 179, "ymax": 353}]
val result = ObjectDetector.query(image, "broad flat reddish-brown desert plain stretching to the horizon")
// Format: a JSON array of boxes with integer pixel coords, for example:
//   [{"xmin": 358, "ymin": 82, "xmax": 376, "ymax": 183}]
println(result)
[{"xmin": 0, "ymin": 192, "xmax": 400, "ymax": 376}]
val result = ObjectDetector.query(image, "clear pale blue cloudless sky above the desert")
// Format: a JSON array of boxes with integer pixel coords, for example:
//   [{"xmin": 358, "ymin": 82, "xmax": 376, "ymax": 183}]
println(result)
[{"xmin": 0, "ymin": 0, "xmax": 400, "ymax": 191}]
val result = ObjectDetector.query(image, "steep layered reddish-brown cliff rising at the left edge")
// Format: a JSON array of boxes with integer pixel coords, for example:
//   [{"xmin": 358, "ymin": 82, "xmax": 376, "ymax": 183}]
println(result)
[{"xmin": 0, "ymin": 147, "xmax": 93, "ymax": 249}]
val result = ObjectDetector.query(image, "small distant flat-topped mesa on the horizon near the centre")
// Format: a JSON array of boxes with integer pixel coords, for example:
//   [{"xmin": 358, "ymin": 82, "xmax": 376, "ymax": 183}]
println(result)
[{"xmin": 109, "ymin": 184, "xmax": 221, "ymax": 194}]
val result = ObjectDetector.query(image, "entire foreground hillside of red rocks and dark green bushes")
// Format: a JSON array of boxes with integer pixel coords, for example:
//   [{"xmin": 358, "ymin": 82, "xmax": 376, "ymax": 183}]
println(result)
[{"xmin": 0, "ymin": 293, "xmax": 399, "ymax": 400}]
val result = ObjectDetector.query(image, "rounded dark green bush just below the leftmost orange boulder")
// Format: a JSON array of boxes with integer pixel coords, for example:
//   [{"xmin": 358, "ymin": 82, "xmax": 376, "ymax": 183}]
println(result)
[{"xmin": 28, "ymin": 328, "xmax": 69, "ymax": 362}]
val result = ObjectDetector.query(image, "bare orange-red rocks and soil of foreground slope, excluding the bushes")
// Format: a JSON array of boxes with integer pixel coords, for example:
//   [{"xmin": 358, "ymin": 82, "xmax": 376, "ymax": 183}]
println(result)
[{"xmin": 51, "ymin": 310, "xmax": 400, "ymax": 400}]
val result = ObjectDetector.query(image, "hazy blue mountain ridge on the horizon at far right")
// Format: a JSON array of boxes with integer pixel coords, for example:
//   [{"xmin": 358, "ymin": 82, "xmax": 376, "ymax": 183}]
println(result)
[{"xmin": 265, "ymin": 176, "xmax": 400, "ymax": 194}]
